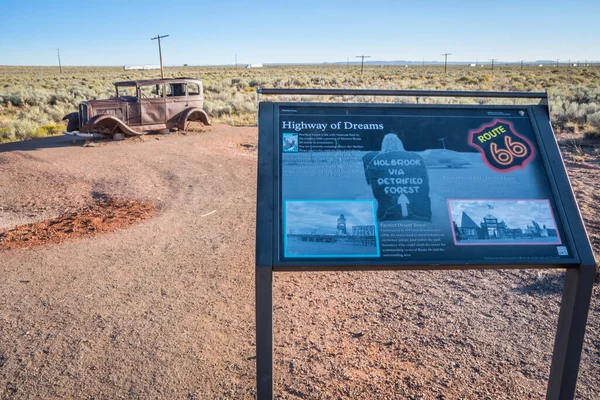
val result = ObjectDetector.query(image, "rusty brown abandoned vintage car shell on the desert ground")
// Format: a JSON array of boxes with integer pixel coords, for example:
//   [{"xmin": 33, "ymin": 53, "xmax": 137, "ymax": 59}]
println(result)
[{"xmin": 63, "ymin": 78, "xmax": 210, "ymax": 138}]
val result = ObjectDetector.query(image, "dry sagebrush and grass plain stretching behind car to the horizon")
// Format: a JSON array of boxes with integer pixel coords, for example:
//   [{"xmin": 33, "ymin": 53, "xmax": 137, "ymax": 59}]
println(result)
[{"xmin": 0, "ymin": 66, "xmax": 600, "ymax": 141}]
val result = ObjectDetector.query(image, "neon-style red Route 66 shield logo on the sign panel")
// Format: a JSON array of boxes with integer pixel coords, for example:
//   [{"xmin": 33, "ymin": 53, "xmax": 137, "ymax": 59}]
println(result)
[{"xmin": 469, "ymin": 119, "xmax": 535, "ymax": 172}]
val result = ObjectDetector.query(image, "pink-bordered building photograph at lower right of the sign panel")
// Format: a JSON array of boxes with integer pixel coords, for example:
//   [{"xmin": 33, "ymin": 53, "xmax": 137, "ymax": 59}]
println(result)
[{"xmin": 448, "ymin": 199, "xmax": 561, "ymax": 245}]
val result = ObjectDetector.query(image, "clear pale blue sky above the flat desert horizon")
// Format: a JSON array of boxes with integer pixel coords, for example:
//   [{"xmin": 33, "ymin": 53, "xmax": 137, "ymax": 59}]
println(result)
[{"xmin": 0, "ymin": 0, "xmax": 600, "ymax": 65}]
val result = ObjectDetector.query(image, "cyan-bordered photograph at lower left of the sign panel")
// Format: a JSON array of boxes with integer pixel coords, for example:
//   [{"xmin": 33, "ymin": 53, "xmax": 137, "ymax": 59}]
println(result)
[{"xmin": 283, "ymin": 200, "xmax": 379, "ymax": 257}]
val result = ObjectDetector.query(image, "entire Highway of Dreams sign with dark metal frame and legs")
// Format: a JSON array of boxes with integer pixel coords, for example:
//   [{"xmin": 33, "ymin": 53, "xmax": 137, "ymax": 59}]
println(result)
[{"xmin": 256, "ymin": 89, "xmax": 595, "ymax": 400}]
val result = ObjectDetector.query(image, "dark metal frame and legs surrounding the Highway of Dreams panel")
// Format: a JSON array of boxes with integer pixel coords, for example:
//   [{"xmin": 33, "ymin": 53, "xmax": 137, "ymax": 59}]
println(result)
[{"xmin": 255, "ymin": 89, "xmax": 596, "ymax": 399}]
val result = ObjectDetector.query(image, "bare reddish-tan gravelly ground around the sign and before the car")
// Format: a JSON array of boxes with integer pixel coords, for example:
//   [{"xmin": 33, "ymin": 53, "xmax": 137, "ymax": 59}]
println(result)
[{"xmin": 0, "ymin": 126, "xmax": 600, "ymax": 399}]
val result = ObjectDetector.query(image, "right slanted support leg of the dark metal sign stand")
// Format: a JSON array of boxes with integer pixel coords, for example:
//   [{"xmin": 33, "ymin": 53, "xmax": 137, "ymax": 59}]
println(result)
[{"xmin": 546, "ymin": 265, "xmax": 596, "ymax": 400}]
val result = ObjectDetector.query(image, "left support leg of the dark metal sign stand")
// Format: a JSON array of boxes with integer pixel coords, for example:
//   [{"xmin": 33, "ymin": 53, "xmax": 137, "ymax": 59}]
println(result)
[{"xmin": 256, "ymin": 267, "xmax": 273, "ymax": 400}]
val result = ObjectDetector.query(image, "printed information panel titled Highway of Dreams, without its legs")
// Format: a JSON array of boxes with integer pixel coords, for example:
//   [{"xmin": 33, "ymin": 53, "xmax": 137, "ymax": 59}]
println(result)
[{"xmin": 259, "ymin": 103, "xmax": 578, "ymax": 267}]
